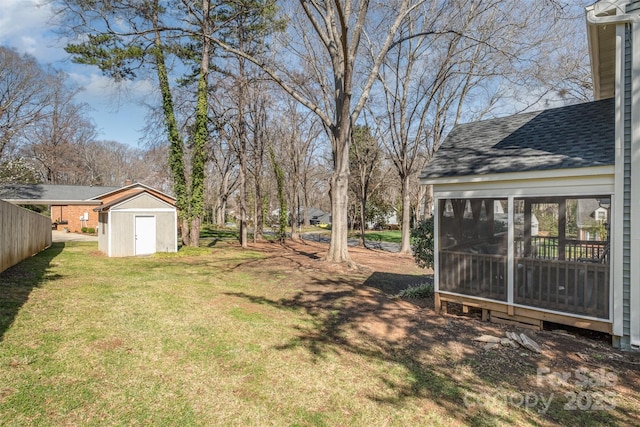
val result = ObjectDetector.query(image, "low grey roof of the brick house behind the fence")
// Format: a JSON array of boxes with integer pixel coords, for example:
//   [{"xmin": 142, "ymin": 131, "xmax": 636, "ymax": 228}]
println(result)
[{"xmin": 0, "ymin": 184, "xmax": 120, "ymax": 205}]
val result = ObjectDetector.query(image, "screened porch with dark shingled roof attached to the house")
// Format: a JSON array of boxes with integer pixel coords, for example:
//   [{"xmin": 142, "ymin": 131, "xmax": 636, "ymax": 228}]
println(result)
[{"xmin": 421, "ymin": 99, "xmax": 616, "ymax": 333}]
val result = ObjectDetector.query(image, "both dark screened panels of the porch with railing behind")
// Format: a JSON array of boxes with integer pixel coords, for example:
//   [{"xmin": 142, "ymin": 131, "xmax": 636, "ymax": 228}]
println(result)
[{"xmin": 438, "ymin": 196, "xmax": 611, "ymax": 318}]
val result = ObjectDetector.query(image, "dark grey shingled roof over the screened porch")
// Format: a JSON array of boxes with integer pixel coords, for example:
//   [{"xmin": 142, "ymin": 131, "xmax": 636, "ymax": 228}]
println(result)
[{"xmin": 420, "ymin": 98, "xmax": 615, "ymax": 179}]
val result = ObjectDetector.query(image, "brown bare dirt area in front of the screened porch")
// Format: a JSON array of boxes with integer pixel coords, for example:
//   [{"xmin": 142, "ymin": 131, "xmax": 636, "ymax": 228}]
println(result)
[{"xmin": 229, "ymin": 241, "xmax": 640, "ymax": 425}]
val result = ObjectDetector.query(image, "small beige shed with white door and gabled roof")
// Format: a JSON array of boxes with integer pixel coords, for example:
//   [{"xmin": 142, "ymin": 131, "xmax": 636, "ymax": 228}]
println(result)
[{"xmin": 94, "ymin": 189, "xmax": 178, "ymax": 257}]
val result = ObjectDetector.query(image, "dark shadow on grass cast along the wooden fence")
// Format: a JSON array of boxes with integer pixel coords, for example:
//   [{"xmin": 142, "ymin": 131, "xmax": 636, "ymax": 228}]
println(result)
[{"xmin": 0, "ymin": 242, "xmax": 64, "ymax": 341}]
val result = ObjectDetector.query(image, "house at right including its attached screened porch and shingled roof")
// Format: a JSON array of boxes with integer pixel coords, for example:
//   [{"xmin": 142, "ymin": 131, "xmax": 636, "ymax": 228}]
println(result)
[{"xmin": 420, "ymin": 0, "xmax": 640, "ymax": 348}]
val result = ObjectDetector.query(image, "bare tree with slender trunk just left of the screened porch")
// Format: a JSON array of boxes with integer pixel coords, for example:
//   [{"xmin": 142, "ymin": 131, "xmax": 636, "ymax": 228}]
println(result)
[{"xmin": 370, "ymin": 0, "xmax": 596, "ymax": 253}]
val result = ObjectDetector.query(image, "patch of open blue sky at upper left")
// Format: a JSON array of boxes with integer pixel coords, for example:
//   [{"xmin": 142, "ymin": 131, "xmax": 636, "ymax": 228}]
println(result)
[{"xmin": 0, "ymin": 0, "xmax": 152, "ymax": 147}]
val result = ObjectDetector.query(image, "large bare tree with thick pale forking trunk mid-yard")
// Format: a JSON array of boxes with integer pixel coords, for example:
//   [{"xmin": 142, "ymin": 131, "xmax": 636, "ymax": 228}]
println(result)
[{"xmin": 213, "ymin": 0, "xmax": 417, "ymax": 264}]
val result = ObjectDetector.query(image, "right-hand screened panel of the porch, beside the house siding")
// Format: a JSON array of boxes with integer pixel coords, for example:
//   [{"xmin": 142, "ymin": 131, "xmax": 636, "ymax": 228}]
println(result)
[{"xmin": 514, "ymin": 197, "xmax": 610, "ymax": 318}]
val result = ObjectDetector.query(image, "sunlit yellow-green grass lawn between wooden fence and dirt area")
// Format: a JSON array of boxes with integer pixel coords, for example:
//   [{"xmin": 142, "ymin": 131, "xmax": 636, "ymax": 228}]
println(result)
[{"xmin": 0, "ymin": 241, "xmax": 638, "ymax": 426}]
